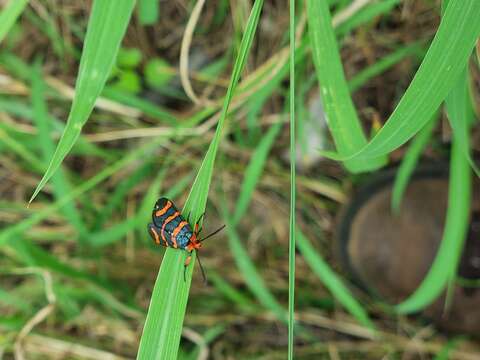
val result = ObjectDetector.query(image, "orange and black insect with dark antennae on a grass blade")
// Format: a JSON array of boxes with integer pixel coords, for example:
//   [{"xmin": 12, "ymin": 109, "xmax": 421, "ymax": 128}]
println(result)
[{"xmin": 148, "ymin": 198, "xmax": 225, "ymax": 281}]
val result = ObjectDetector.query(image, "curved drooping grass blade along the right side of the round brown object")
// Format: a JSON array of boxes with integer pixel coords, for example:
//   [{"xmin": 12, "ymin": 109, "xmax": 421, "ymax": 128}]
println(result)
[{"xmin": 396, "ymin": 78, "xmax": 472, "ymax": 314}]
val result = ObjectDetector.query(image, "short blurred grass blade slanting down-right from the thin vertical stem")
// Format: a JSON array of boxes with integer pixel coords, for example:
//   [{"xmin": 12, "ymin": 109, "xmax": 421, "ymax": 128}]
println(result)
[{"xmin": 297, "ymin": 229, "xmax": 375, "ymax": 330}]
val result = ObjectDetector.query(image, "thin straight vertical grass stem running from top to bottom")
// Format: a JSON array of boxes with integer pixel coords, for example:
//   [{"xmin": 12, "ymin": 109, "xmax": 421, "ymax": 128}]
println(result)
[{"xmin": 288, "ymin": 0, "xmax": 297, "ymax": 360}]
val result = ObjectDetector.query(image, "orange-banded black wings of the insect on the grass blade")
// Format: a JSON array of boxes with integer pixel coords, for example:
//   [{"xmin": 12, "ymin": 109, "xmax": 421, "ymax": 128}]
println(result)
[{"xmin": 152, "ymin": 198, "xmax": 193, "ymax": 249}]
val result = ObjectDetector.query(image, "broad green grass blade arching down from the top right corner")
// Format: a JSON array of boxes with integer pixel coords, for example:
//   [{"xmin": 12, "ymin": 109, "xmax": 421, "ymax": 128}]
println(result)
[{"xmin": 324, "ymin": 0, "xmax": 480, "ymax": 161}]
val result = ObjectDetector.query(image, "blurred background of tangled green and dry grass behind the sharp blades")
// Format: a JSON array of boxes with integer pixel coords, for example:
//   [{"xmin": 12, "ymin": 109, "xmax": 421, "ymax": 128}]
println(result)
[{"xmin": 0, "ymin": 0, "xmax": 480, "ymax": 359}]
